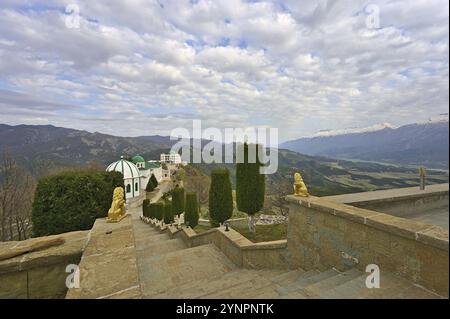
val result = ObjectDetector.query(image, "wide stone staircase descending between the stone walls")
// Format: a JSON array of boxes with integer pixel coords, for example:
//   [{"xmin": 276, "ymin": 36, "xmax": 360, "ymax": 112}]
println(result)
[{"xmin": 133, "ymin": 218, "xmax": 440, "ymax": 299}]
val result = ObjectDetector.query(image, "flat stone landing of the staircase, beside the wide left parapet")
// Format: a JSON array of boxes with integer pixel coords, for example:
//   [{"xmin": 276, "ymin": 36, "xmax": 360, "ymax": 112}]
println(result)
[{"xmin": 139, "ymin": 244, "xmax": 236, "ymax": 298}]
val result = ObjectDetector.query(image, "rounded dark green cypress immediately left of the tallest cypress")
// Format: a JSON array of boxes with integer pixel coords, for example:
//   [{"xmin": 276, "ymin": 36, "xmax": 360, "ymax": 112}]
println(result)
[{"xmin": 209, "ymin": 168, "xmax": 233, "ymax": 223}]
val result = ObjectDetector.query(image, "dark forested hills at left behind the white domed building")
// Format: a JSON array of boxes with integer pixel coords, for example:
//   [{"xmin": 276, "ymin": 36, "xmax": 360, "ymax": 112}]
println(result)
[{"xmin": 0, "ymin": 124, "xmax": 170, "ymax": 175}]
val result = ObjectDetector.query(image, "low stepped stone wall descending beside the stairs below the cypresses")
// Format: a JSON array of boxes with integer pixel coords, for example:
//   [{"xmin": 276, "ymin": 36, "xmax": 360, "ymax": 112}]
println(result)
[{"xmin": 148, "ymin": 220, "xmax": 288, "ymax": 269}]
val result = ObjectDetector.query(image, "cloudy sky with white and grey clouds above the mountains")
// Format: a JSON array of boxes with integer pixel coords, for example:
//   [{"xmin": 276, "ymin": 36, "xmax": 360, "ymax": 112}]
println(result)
[{"xmin": 0, "ymin": 0, "xmax": 449, "ymax": 140}]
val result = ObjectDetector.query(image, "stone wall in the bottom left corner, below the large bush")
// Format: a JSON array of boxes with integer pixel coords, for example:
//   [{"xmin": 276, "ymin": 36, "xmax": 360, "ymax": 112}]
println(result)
[{"xmin": 0, "ymin": 231, "xmax": 89, "ymax": 299}]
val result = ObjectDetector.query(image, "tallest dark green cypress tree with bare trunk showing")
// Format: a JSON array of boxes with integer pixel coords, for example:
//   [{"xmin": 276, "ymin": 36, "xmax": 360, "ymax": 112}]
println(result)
[{"xmin": 236, "ymin": 143, "xmax": 265, "ymax": 232}]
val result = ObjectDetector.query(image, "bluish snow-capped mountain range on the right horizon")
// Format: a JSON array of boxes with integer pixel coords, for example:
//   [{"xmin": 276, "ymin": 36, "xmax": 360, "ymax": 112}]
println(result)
[{"xmin": 280, "ymin": 119, "xmax": 449, "ymax": 169}]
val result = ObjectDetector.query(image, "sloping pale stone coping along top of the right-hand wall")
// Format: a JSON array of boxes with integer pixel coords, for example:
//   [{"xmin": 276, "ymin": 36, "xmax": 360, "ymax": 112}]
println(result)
[{"xmin": 286, "ymin": 195, "xmax": 449, "ymax": 251}]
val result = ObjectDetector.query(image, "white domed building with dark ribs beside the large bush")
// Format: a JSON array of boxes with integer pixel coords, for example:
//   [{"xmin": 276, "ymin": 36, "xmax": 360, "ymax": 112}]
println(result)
[{"xmin": 106, "ymin": 157, "xmax": 142, "ymax": 199}]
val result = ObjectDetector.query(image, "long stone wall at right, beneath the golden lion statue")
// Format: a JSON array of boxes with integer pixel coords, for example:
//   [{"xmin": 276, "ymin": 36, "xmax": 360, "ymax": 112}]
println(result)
[{"xmin": 286, "ymin": 196, "xmax": 449, "ymax": 296}]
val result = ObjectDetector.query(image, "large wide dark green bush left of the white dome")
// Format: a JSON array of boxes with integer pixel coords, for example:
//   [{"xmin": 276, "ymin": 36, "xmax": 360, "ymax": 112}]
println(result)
[{"xmin": 31, "ymin": 170, "xmax": 124, "ymax": 237}]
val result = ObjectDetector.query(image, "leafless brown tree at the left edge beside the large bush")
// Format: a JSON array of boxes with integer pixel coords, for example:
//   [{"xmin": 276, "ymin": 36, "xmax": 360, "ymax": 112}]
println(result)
[{"xmin": 0, "ymin": 151, "xmax": 35, "ymax": 241}]
